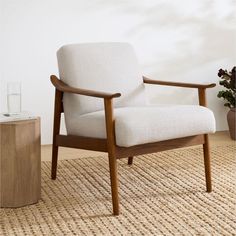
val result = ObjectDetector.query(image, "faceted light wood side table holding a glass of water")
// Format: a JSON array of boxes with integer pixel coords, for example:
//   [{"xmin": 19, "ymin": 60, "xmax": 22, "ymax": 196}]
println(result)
[{"xmin": 0, "ymin": 118, "xmax": 41, "ymax": 207}]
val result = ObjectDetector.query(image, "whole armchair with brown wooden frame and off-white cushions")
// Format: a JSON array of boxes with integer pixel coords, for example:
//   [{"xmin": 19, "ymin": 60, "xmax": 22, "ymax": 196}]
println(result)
[{"xmin": 51, "ymin": 43, "xmax": 215, "ymax": 215}]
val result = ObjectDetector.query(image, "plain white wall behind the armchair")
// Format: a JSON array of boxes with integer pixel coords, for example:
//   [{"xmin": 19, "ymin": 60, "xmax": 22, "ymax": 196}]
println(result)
[{"xmin": 0, "ymin": 0, "xmax": 236, "ymax": 143}]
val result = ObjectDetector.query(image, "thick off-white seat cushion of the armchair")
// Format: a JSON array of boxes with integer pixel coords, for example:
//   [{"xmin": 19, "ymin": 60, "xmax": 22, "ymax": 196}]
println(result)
[{"xmin": 67, "ymin": 105, "xmax": 215, "ymax": 147}]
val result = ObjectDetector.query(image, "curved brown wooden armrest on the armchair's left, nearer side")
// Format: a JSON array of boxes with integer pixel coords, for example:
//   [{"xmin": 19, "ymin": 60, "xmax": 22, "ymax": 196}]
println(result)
[{"xmin": 50, "ymin": 75, "xmax": 121, "ymax": 99}]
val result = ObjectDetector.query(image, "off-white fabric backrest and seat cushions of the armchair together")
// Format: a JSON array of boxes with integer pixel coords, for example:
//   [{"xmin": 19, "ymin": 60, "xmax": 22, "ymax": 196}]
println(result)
[{"xmin": 57, "ymin": 43, "xmax": 215, "ymax": 147}]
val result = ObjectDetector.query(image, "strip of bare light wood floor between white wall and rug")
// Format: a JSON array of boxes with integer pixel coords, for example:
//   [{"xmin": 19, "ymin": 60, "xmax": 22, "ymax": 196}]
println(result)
[{"xmin": 41, "ymin": 131, "xmax": 236, "ymax": 161}]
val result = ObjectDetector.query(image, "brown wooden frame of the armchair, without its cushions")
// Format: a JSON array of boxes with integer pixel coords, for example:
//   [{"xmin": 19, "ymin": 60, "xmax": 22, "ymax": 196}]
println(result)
[{"xmin": 50, "ymin": 75, "xmax": 215, "ymax": 215}]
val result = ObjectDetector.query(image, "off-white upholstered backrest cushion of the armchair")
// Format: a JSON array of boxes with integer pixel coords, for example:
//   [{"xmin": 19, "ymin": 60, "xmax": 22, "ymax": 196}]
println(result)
[{"xmin": 57, "ymin": 43, "xmax": 146, "ymax": 118}]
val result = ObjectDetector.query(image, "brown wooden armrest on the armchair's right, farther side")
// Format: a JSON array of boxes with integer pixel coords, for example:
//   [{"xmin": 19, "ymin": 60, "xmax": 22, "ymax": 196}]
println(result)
[{"xmin": 143, "ymin": 76, "xmax": 216, "ymax": 89}]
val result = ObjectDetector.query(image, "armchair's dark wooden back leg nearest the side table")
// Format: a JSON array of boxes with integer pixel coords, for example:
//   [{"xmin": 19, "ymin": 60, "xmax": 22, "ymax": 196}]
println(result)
[{"xmin": 51, "ymin": 89, "xmax": 63, "ymax": 179}]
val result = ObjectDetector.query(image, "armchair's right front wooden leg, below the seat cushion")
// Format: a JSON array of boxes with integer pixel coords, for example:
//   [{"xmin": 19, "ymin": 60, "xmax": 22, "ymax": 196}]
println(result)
[{"xmin": 203, "ymin": 134, "xmax": 212, "ymax": 193}]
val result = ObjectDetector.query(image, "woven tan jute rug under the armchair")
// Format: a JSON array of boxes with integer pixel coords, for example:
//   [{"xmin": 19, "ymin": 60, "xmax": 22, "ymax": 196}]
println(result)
[{"xmin": 0, "ymin": 146, "xmax": 236, "ymax": 236}]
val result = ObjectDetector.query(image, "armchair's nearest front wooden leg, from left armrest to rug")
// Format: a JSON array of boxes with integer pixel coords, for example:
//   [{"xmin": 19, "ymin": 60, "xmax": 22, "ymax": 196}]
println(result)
[{"xmin": 104, "ymin": 99, "xmax": 119, "ymax": 215}]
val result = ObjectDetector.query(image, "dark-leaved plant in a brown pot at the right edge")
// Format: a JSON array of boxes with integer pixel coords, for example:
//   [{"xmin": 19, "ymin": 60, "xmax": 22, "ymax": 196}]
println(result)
[{"xmin": 217, "ymin": 66, "xmax": 236, "ymax": 140}]
